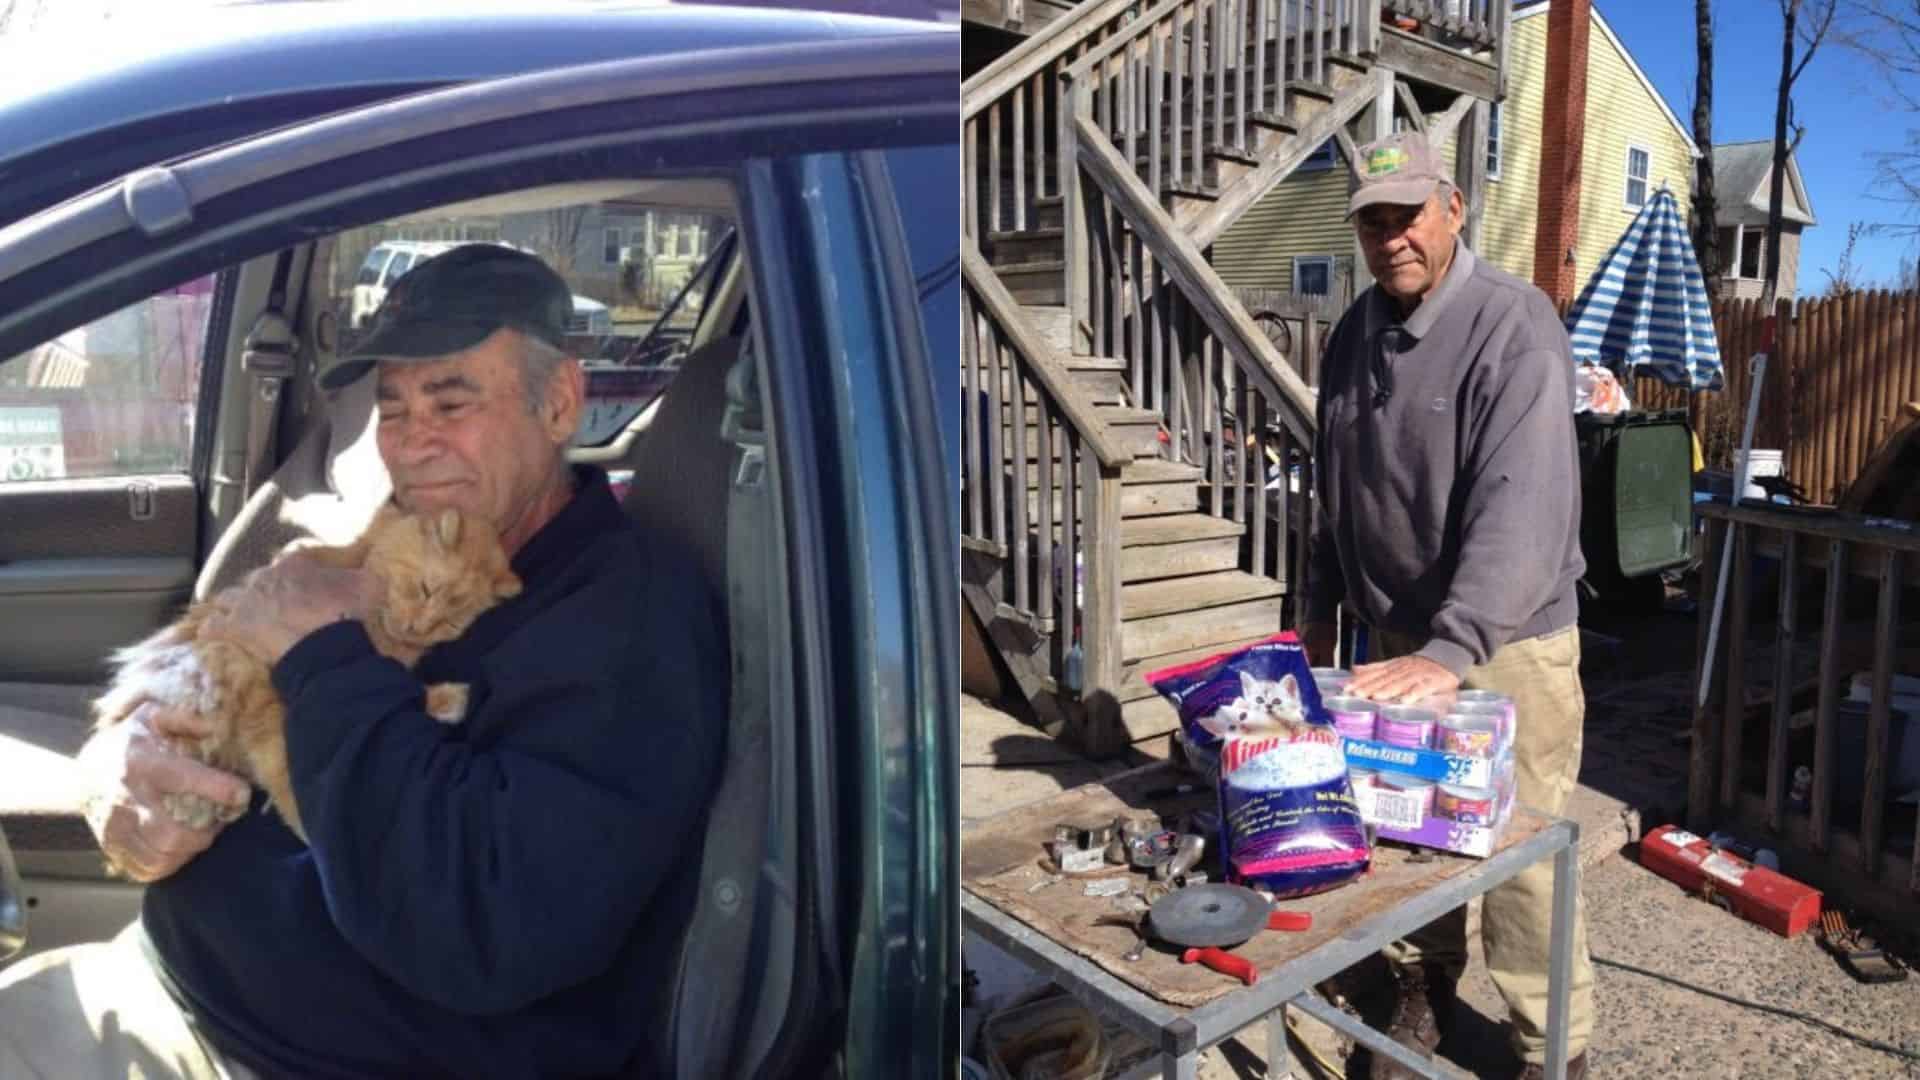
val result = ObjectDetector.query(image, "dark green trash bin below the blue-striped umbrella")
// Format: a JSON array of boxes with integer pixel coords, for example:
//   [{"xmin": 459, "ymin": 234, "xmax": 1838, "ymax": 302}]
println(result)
[{"xmin": 1574, "ymin": 409, "xmax": 1693, "ymax": 598}]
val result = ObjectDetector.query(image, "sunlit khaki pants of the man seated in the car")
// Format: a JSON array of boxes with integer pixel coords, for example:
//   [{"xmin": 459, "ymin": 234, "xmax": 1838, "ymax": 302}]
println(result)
[{"xmin": 0, "ymin": 914, "xmax": 257, "ymax": 1080}]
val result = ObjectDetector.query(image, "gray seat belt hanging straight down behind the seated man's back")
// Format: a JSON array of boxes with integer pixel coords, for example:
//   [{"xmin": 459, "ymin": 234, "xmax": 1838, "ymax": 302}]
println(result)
[{"xmin": 674, "ymin": 338, "xmax": 774, "ymax": 1076}]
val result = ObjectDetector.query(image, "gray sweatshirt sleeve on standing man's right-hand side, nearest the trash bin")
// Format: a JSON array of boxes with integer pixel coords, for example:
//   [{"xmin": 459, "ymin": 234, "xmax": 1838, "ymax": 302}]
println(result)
[{"xmin": 1419, "ymin": 338, "xmax": 1580, "ymax": 675}]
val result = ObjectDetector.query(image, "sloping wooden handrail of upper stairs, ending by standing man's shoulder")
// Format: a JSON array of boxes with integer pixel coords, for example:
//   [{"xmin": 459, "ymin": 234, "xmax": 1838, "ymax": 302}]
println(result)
[{"xmin": 1073, "ymin": 115, "xmax": 1315, "ymax": 442}]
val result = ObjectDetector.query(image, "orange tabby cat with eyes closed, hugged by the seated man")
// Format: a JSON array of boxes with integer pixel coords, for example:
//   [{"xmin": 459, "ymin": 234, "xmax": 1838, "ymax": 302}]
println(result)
[{"xmin": 94, "ymin": 505, "xmax": 520, "ymax": 840}]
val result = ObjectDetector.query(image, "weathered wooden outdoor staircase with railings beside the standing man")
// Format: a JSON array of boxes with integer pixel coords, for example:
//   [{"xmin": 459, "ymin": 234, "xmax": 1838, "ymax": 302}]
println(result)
[{"xmin": 962, "ymin": 0, "xmax": 1505, "ymax": 753}]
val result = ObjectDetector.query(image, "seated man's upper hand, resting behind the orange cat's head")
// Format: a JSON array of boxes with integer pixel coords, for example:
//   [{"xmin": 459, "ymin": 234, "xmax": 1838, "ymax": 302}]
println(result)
[{"xmin": 202, "ymin": 552, "xmax": 380, "ymax": 665}]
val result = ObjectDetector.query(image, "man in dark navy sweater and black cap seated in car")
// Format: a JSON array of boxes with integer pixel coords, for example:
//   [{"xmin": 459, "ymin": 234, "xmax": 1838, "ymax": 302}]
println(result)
[{"xmin": 0, "ymin": 244, "xmax": 728, "ymax": 1078}]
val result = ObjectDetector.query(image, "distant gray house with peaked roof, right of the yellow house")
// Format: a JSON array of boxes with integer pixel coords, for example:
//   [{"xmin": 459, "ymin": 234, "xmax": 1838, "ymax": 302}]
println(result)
[{"xmin": 1713, "ymin": 138, "xmax": 1818, "ymax": 300}]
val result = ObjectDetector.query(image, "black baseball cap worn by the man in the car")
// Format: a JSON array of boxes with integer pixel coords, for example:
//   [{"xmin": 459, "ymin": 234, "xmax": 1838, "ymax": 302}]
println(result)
[{"xmin": 321, "ymin": 244, "xmax": 574, "ymax": 390}]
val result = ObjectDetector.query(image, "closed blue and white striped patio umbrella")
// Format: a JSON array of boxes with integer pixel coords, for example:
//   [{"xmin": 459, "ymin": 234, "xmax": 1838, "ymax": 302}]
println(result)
[{"xmin": 1567, "ymin": 188, "xmax": 1720, "ymax": 390}]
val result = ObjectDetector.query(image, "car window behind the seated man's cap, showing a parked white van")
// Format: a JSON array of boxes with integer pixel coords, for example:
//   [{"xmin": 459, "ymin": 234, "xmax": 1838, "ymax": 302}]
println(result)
[{"xmin": 323, "ymin": 193, "xmax": 733, "ymax": 446}]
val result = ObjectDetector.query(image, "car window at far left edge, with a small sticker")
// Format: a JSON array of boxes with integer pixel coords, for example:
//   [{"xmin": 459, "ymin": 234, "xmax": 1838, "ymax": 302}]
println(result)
[{"xmin": 0, "ymin": 277, "xmax": 213, "ymax": 482}]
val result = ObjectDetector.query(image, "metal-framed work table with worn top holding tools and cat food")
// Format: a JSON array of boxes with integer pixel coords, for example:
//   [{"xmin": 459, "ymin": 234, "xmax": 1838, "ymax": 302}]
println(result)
[{"xmin": 960, "ymin": 765, "xmax": 1580, "ymax": 1080}]
